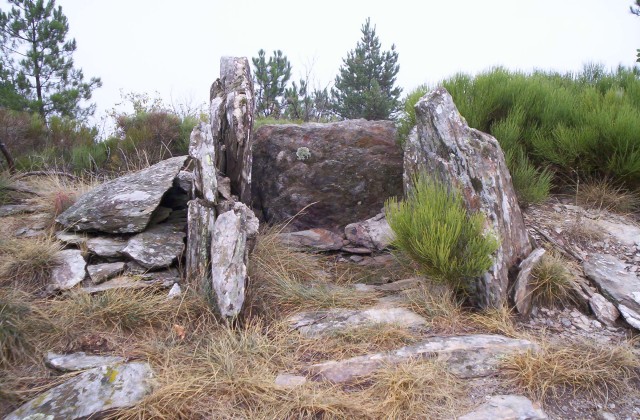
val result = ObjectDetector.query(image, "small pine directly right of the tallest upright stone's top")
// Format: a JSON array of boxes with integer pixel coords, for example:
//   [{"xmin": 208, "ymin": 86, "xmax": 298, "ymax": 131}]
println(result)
[{"xmin": 252, "ymin": 49, "xmax": 291, "ymax": 118}]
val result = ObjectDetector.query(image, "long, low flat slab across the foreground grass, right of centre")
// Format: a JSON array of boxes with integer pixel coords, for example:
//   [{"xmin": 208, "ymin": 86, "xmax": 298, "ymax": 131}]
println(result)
[{"xmin": 306, "ymin": 334, "xmax": 537, "ymax": 383}]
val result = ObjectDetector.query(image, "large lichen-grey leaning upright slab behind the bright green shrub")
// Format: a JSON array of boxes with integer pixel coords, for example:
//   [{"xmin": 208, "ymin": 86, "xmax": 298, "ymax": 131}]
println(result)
[{"xmin": 404, "ymin": 88, "xmax": 531, "ymax": 307}]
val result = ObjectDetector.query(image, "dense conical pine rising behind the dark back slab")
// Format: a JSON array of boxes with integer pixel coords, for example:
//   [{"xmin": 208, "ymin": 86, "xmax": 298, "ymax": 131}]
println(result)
[{"xmin": 331, "ymin": 18, "xmax": 402, "ymax": 120}]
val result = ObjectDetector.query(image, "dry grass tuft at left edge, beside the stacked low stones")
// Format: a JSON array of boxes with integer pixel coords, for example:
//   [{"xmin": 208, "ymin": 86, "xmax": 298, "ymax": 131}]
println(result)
[{"xmin": 0, "ymin": 237, "xmax": 62, "ymax": 291}]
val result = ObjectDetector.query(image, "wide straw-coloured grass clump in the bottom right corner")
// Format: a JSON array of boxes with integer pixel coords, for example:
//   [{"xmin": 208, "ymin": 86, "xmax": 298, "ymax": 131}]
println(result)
[{"xmin": 502, "ymin": 341, "xmax": 640, "ymax": 401}]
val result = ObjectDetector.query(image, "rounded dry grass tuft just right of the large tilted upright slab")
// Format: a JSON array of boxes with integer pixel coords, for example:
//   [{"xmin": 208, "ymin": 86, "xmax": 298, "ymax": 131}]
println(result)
[{"xmin": 530, "ymin": 252, "xmax": 574, "ymax": 306}]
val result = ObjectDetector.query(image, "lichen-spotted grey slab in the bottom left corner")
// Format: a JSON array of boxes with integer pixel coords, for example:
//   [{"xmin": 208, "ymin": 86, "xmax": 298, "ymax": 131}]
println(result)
[{"xmin": 5, "ymin": 362, "xmax": 153, "ymax": 420}]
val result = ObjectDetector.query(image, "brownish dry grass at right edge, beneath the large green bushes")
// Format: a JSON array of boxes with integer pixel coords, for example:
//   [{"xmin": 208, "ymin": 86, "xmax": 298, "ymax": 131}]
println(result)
[{"xmin": 576, "ymin": 179, "xmax": 640, "ymax": 214}]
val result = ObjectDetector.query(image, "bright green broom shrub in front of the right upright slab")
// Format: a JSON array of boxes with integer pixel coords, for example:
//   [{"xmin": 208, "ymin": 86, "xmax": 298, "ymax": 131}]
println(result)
[{"xmin": 385, "ymin": 175, "xmax": 499, "ymax": 292}]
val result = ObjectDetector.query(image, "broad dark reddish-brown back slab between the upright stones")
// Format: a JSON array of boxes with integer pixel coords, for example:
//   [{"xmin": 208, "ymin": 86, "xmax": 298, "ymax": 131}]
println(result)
[{"xmin": 253, "ymin": 120, "xmax": 402, "ymax": 233}]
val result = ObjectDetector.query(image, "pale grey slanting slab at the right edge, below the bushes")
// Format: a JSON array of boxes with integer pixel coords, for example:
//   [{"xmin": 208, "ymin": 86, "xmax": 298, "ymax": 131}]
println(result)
[{"xmin": 582, "ymin": 254, "xmax": 640, "ymax": 329}]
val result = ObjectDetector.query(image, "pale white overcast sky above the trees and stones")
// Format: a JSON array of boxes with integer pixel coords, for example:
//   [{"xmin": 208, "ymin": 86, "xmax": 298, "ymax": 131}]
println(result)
[{"xmin": 0, "ymin": 0, "xmax": 640, "ymax": 131}]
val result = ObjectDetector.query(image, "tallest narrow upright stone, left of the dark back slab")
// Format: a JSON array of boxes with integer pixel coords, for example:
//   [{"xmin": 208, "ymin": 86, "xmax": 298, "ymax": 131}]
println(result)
[{"xmin": 211, "ymin": 57, "xmax": 254, "ymax": 204}]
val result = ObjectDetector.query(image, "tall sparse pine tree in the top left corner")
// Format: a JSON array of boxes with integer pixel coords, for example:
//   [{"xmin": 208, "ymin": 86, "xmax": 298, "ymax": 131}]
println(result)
[{"xmin": 0, "ymin": 0, "xmax": 102, "ymax": 120}]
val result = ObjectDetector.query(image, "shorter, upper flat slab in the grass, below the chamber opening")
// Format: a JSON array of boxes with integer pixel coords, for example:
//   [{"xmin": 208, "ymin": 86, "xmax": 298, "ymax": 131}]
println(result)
[{"xmin": 288, "ymin": 307, "xmax": 427, "ymax": 337}]
